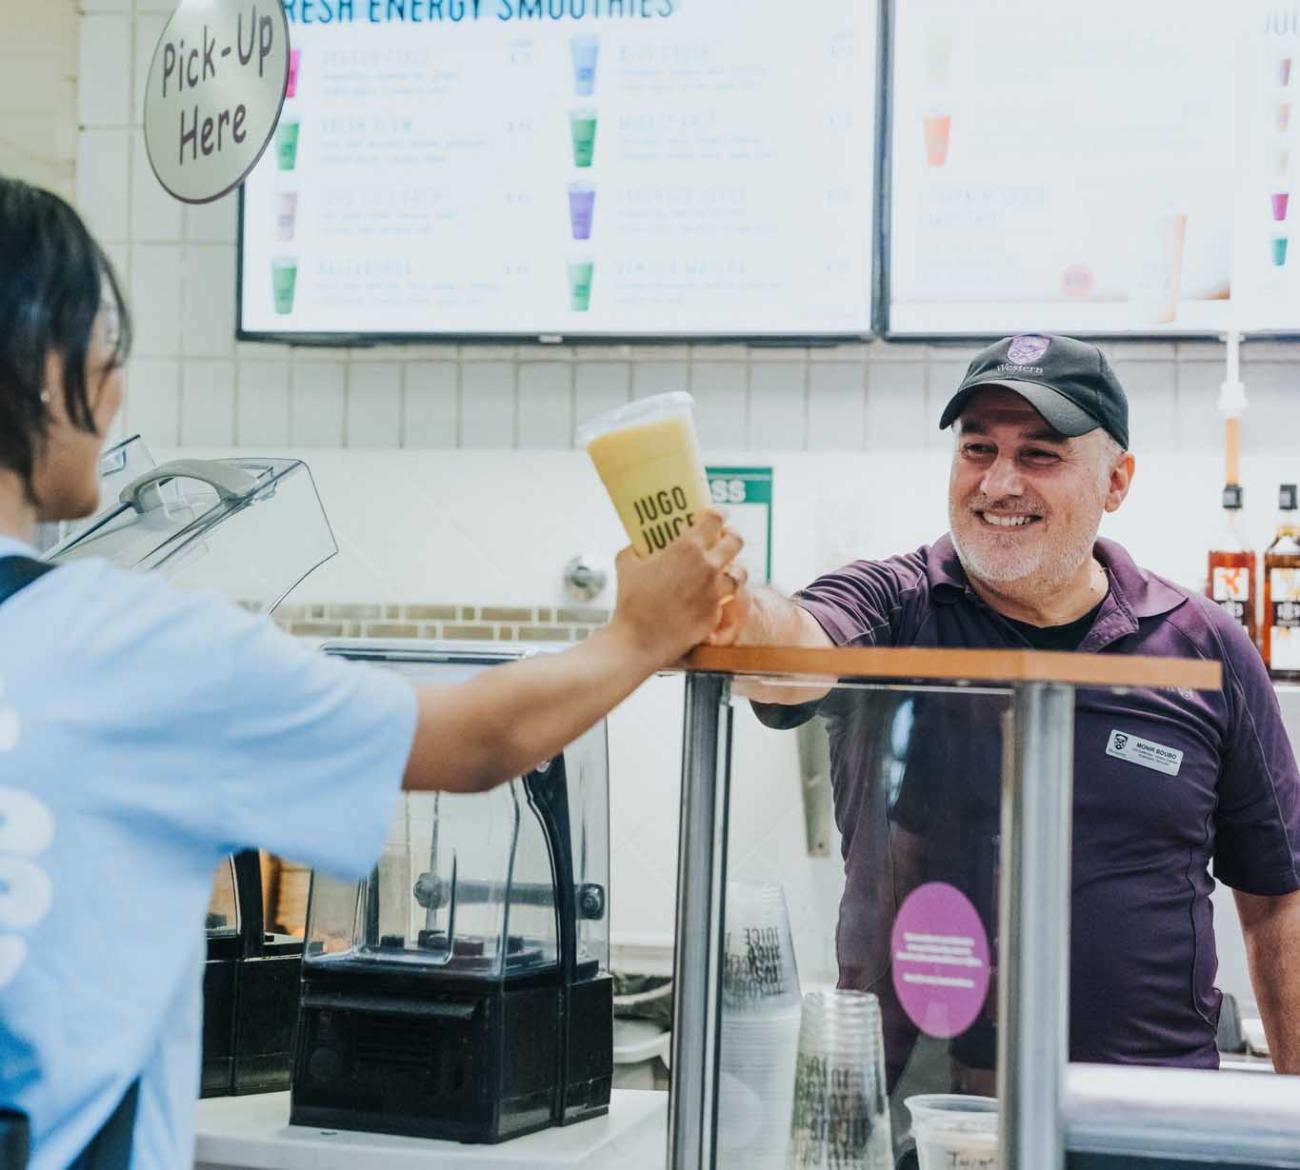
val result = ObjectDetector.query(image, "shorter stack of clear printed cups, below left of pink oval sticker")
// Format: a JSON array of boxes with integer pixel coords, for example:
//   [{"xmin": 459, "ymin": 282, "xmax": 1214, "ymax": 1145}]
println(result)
[{"xmin": 787, "ymin": 991, "xmax": 893, "ymax": 1170}]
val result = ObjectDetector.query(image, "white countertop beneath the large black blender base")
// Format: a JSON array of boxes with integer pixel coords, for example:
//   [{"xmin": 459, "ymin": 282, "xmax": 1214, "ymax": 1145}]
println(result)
[{"xmin": 195, "ymin": 1089, "xmax": 668, "ymax": 1170}]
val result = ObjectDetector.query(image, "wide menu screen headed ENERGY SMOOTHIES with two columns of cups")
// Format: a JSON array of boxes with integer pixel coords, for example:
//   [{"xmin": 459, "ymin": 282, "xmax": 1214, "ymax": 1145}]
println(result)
[{"xmin": 239, "ymin": 0, "xmax": 878, "ymax": 338}]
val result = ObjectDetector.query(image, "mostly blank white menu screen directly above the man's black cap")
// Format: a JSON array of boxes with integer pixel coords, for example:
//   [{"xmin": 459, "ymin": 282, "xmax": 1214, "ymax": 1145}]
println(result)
[{"xmin": 889, "ymin": 0, "xmax": 1244, "ymax": 334}]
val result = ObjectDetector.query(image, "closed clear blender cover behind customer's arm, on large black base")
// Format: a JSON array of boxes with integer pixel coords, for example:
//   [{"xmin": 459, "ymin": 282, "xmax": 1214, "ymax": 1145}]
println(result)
[{"xmin": 306, "ymin": 644, "xmax": 608, "ymax": 979}]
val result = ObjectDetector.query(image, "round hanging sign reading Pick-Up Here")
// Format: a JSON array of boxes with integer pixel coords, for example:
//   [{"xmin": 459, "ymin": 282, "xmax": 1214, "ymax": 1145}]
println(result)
[{"xmin": 144, "ymin": 0, "xmax": 289, "ymax": 203}]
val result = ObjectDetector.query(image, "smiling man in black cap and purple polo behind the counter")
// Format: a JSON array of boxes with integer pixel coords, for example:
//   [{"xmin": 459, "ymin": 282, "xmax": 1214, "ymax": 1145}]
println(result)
[{"xmin": 714, "ymin": 335, "xmax": 1300, "ymax": 1089}]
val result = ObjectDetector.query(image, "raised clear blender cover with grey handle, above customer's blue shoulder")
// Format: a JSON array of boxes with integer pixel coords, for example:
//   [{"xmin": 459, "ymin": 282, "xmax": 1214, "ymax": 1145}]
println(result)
[{"xmin": 49, "ymin": 459, "xmax": 338, "ymax": 612}]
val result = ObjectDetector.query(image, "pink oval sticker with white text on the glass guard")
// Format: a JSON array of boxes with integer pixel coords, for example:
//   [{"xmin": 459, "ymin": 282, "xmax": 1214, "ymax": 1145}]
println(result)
[{"xmin": 889, "ymin": 881, "xmax": 989, "ymax": 1040}]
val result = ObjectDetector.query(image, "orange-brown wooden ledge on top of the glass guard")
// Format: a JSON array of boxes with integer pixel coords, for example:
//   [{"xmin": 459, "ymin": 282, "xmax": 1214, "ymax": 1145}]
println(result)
[{"xmin": 679, "ymin": 646, "xmax": 1223, "ymax": 690}]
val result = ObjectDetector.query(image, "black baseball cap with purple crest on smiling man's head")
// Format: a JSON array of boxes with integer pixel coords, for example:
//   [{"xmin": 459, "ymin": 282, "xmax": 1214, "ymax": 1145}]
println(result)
[{"xmin": 939, "ymin": 333, "xmax": 1128, "ymax": 451}]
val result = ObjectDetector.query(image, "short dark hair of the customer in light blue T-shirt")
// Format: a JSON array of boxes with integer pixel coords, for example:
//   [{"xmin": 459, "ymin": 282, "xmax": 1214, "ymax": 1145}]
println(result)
[{"xmin": 0, "ymin": 176, "xmax": 130, "ymax": 502}]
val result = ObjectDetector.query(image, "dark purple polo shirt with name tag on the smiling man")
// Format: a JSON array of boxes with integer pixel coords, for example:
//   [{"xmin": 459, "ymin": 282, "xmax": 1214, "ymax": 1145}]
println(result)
[{"xmin": 755, "ymin": 536, "xmax": 1300, "ymax": 1074}]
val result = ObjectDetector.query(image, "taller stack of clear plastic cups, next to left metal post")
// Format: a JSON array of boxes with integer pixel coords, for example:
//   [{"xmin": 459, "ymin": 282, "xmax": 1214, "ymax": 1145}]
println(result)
[{"xmin": 718, "ymin": 881, "xmax": 800, "ymax": 1170}]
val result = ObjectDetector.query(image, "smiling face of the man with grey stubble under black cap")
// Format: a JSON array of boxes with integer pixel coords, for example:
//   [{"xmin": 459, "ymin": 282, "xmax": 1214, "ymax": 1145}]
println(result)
[{"xmin": 948, "ymin": 386, "xmax": 1123, "ymax": 592}]
